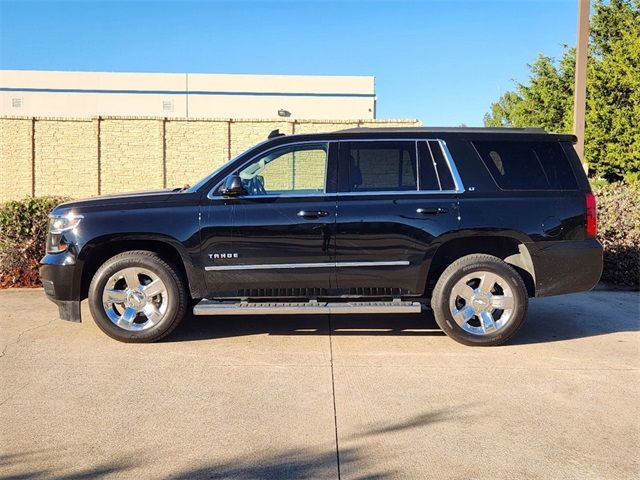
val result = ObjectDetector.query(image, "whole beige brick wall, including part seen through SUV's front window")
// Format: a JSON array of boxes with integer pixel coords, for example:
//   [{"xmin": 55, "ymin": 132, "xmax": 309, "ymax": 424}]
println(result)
[{"xmin": 0, "ymin": 117, "xmax": 420, "ymax": 202}]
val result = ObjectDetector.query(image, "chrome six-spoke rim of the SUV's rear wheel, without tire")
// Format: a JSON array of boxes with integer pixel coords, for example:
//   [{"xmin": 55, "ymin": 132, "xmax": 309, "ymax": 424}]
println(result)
[{"xmin": 449, "ymin": 271, "xmax": 515, "ymax": 335}]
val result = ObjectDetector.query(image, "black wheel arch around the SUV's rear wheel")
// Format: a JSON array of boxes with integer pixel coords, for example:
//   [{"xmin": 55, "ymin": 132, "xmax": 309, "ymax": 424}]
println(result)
[{"xmin": 425, "ymin": 233, "xmax": 536, "ymax": 297}]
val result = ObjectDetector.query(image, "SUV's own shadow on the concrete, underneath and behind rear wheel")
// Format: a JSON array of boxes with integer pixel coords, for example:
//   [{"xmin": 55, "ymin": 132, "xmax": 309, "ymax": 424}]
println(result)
[{"xmin": 165, "ymin": 292, "xmax": 640, "ymax": 345}]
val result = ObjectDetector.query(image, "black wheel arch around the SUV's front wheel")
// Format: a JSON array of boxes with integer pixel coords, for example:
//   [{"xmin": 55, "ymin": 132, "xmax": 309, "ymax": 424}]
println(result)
[{"xmin": 78, "ymin": 235, "xmax": 203, "ymax": 299}]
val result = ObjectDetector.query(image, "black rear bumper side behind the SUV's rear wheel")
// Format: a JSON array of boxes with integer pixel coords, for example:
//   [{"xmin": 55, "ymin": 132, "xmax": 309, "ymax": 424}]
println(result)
[{"xmin": 527, "ymin": 239, "xmax": 602, "ymax": 297}]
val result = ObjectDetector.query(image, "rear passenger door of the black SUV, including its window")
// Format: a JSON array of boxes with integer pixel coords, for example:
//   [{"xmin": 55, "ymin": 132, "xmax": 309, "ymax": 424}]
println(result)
[{"xmin": 336, "ymin": 140, "xmax": 462, "ymax": 296}]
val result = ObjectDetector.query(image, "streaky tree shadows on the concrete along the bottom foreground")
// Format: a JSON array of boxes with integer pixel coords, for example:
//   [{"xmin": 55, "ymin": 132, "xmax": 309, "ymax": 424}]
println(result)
[{"xmin": 0, "ymin": 403, "xmax": 474, "ymax": 480}]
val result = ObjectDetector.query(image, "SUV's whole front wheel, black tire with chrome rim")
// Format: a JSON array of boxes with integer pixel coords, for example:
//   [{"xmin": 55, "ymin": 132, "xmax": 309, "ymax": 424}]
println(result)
[{"xmin": 89, "ymin": 250, "xmax": 189, "ymax": 343}]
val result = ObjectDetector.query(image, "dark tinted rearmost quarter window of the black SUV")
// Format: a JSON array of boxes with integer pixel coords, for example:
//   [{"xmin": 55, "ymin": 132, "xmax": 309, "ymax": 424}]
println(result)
[{"xmin": 473, "ymin": 141, "xmax": 578, "ymax": 190}]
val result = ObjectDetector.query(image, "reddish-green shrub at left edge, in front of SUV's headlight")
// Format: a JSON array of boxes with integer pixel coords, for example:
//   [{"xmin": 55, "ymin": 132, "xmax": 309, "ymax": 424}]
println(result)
[{"xmin": 0, "ymin": 197, "xmax": 66, "ymax": 288}]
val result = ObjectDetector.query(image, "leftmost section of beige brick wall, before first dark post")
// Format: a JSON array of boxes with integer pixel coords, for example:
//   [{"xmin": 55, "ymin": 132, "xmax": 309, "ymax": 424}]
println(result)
[{"xmin": 0, "ymin": 118, "xmax": 32, "ymax": 200}]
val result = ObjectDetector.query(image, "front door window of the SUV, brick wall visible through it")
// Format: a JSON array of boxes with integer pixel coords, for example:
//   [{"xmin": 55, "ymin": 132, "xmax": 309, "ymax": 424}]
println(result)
[{"xmin": 239, "ymin": 143, "xmax": 327, "ymax": 196}]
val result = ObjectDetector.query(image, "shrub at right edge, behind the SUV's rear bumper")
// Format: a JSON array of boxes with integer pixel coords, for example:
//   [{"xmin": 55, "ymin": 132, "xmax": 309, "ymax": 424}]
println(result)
[{"xmin": 593, "ymin": 182, "xmax": 640, "ymax": 289}]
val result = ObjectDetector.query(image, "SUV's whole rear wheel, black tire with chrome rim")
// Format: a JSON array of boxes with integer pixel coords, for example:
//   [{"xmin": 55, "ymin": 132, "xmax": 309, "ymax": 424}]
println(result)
[{"xmin": 431, "ymin": 254, "xmax": 529, "ymax": 346}]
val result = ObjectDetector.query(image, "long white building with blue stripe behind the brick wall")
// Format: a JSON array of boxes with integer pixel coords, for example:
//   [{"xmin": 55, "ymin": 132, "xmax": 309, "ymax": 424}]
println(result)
[{"xmin": 0, "ymin": 70, "xmax": 376, "ymax": 119}]
